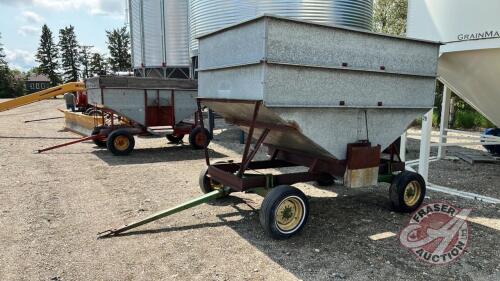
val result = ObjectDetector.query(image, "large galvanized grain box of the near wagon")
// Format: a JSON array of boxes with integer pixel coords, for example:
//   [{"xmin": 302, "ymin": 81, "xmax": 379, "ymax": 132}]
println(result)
[{"xmin": 198, "ymin": 15, "xmax": 439, "ymax": 186}]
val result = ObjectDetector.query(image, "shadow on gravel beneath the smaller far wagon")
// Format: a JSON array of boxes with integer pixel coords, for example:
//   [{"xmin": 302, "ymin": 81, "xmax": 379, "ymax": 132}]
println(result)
[{"xmin": 92, "ymin": 145, "xmax": 227, "ymax": 166}]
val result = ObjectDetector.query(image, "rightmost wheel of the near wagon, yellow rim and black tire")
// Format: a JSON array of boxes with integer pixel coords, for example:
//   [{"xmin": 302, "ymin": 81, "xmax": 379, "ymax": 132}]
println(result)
[{"xmin": 389, "ymin": 171, "xmax": 426, "ymax": 213}]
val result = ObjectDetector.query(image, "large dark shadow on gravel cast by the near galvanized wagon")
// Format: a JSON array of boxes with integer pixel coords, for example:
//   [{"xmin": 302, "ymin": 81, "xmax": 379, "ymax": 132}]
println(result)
[{"xmin": 101, "ymin": 183, "xmax": 497, "ymax": 280}]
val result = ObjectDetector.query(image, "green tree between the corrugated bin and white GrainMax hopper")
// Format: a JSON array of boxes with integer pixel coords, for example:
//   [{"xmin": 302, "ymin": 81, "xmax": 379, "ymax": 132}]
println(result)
[{"xmin": 373, "ymin": 0, "xmax": 408, "ymax": 35}]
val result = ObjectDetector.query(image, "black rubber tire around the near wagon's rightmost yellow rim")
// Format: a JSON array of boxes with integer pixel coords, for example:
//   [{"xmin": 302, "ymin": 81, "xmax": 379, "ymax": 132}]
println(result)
[{"xmin": 389, "ymin": 171, "xmax": 426, "ymax": 213}]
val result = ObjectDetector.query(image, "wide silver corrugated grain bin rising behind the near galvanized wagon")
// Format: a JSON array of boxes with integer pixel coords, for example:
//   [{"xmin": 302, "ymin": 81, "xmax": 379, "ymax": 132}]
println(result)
[{"xmin": 189, "ymin": 0, "xmax": 373, "ymax": 56}]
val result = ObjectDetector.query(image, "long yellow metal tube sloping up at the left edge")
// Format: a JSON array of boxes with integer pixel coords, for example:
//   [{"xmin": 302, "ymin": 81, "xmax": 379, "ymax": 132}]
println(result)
[{"xmin": 0, "ymin": 82, "xmax": 86, "ymax": 112}]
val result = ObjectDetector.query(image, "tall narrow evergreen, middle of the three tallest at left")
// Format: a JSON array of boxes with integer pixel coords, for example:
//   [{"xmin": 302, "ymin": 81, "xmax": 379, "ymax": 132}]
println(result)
[{"xmin": 59, "ymin": 25, "xmax": 80, "ymax": 82}]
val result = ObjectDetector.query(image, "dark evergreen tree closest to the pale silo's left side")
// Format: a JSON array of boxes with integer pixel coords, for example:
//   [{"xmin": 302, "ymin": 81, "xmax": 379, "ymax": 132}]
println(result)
[{"xmin": 106, "ymin": 26, "xmax": 132, "ymax": 71}]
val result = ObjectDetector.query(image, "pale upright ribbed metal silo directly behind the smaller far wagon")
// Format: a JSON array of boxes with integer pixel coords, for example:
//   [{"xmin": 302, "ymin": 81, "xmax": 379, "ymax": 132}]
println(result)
[{"xmin": 129, "ymin": 0, "xmax": 190, "ymax": 78}]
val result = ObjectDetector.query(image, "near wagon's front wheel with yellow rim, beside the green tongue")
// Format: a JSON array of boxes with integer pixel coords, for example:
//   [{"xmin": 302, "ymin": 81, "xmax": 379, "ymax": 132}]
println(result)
[{"xmin": 260, "ymin": 185, "xmax": 309, "ymax": 239}]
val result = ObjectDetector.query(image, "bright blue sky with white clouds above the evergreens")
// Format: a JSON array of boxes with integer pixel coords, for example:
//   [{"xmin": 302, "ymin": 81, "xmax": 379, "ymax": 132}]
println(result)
[{"xmin": 0, "ymin": 0, "xmax": 126, "ymax": 71}]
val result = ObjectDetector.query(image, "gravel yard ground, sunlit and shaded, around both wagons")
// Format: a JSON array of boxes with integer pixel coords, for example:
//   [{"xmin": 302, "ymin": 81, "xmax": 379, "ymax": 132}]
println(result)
[{"xmin": 0, "ymin": 100, "xmax": 500, "ymax": 280}]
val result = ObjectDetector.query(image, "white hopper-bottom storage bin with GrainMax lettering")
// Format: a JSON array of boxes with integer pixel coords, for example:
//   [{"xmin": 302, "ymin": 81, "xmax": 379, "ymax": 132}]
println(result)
[{"xmin": 407, "ymin": 0, "xmax": 500, "ymax": 126}]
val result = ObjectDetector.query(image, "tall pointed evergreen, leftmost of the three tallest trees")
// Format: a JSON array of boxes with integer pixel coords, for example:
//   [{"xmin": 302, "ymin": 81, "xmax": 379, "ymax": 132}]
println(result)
[{"xmin": 36, "ymin": 24, "xmax": 61, "ymax": 86}]
